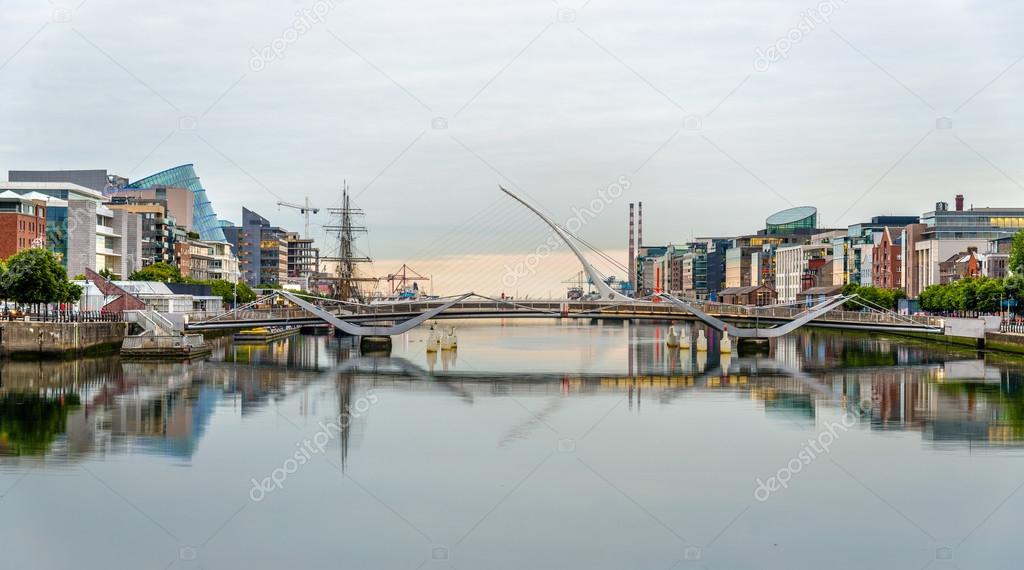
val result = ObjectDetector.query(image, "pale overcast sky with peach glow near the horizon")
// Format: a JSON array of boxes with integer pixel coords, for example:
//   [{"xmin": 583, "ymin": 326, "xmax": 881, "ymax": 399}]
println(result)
[{"xmin": 0, "ymin": 0, "xmax": 1024, "ymax": 296}]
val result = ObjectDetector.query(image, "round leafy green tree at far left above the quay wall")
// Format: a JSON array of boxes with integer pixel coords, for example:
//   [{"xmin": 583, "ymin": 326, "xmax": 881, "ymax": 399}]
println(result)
[{"xmin": 0, "ymin": 248, "xmax": 71, "ymax": 304}]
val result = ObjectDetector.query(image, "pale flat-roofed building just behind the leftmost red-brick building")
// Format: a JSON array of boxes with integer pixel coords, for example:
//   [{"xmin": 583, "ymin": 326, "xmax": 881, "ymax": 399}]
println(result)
[{"xmin": 0, "ymin": 182, "xmax": 142, "ymax": 276}]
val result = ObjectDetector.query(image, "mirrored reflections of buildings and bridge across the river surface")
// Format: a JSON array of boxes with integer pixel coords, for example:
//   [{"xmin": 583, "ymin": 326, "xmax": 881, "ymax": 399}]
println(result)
[{"xmin": 0, "ymin": 323, "xmax": 1024, "ymax": 467}]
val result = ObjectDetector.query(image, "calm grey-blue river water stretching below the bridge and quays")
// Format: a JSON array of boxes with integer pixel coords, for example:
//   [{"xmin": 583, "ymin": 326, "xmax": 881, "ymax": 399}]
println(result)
[{"xmin": 0, "ymin": 321, "xmax": 1024, "ymax": 570}]
